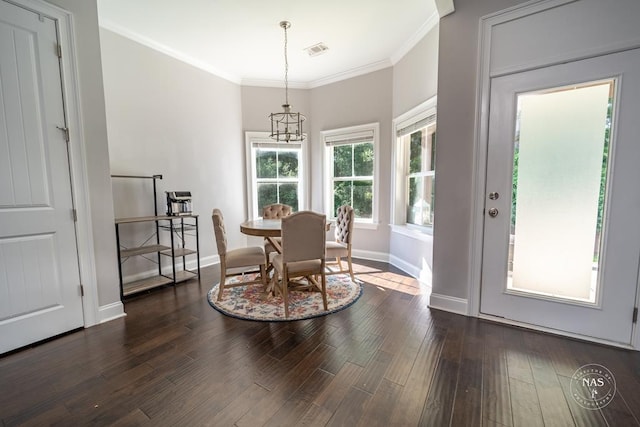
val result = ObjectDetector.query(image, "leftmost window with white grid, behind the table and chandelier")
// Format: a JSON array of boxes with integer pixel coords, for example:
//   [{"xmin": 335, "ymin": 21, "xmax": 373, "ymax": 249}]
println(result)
[{"xmin": 247, "ymin": 132, "xmax": 304, "ymax": 218}]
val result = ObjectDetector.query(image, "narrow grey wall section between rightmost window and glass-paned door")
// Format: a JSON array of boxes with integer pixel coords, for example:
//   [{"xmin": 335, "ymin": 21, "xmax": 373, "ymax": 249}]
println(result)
[{"xmin": 433, "ymin": 0, "xmax": 522, "ymax": 300}]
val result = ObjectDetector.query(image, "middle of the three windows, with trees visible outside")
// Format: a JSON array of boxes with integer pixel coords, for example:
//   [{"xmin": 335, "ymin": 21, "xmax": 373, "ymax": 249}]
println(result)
[{"xmin": 321, "ymin": 123, "xmax": 379, "ymax": 223}]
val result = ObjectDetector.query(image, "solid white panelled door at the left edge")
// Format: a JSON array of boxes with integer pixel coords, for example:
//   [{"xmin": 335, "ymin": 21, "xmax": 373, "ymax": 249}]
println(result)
[{"xmin": 0, "ymin": 0, "xmax": 83, "ymax": 353}]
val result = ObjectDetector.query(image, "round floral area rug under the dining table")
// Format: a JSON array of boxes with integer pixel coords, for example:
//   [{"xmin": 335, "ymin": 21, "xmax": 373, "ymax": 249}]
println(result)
[{"xmin": 207, "ymin": 274, "xmax": 362, "ymax": 322}]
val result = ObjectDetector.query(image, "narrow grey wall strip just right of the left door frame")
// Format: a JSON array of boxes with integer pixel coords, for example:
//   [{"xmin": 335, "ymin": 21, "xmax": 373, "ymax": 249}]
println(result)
[{"xmin": 49, "ymin": 0, "xmax": 120, "ymax": 307}]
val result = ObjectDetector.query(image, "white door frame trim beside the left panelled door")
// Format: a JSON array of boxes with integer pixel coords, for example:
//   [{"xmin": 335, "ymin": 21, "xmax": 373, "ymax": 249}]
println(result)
[{"xmin": 5, "ymin": 0, "xmax": 100, "ymax": 327}]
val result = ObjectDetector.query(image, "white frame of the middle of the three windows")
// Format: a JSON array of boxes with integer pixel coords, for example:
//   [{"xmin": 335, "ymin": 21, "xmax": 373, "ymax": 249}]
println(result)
[{"xmin": 320, "ymin": 122, "xmax": 380, "ymax": 228}]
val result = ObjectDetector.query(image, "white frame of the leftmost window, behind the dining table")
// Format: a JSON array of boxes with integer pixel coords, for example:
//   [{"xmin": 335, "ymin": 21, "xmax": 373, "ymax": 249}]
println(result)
[{"xmin": 245, "ymin": 132, "xmax": 307, "ymax": 219}]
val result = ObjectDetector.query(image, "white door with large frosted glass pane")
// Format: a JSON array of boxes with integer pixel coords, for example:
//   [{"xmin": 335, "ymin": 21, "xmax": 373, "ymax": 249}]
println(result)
[{"xmin": 480, "ymin": 49, "xmax": 640, "ymax": 344}]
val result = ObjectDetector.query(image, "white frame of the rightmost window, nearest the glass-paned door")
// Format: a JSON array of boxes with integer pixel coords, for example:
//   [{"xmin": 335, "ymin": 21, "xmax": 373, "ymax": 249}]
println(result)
[{"xmin": 391, "ymin": 96, "xmax": 438, "ymax": 234}]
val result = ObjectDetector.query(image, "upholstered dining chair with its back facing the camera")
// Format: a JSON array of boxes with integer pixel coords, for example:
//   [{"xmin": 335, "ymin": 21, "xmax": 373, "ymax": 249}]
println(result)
[{"xmin": 271, "ymin": 211, "xmax": 327, "ymax": 317}]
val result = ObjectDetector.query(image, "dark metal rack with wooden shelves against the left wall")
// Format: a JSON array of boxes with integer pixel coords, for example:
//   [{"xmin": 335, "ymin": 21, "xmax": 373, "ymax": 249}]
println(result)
[{"xmin": 112, "ymin": 175, "xmax": 200, "ymax": 299}]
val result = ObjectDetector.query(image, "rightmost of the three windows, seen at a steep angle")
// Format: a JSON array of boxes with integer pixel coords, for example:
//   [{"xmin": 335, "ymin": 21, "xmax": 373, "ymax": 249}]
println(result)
[{"xmin": 393, "ymin": 97, "xmax": 436, "ymax": 229}]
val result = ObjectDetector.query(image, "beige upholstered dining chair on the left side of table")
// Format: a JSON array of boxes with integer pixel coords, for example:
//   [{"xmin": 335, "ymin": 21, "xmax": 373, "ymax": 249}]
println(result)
[{"xmin": 211, "ymin": 209, "xmax": 267, "ymax": 301}]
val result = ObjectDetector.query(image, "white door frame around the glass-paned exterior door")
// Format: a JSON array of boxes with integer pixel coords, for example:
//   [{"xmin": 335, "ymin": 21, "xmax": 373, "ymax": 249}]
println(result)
[{"xmin": 467, "ymin": 0, "xmax": 640, "ymax": 350}]
